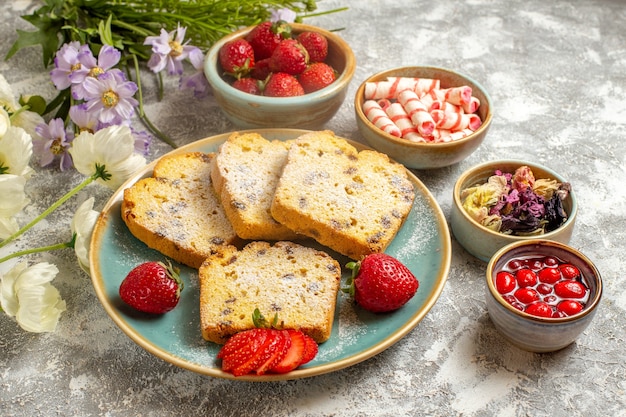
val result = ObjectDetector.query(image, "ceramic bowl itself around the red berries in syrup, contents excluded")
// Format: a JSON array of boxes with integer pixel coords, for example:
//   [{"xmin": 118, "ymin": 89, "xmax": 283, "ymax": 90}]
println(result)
[{"xmin": 485, "ymin": 239, "xmax": 602, "ymax": 352}]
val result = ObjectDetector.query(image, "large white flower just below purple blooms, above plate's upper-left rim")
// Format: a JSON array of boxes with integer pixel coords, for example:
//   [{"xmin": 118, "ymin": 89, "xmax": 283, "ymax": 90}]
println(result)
[{"xmin": 69, "ymin": 125, "xmax": 146, "ymax": 190}]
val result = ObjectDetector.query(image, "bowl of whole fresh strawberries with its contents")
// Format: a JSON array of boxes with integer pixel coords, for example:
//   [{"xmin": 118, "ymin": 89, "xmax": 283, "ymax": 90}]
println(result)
[{"xmin": 204, "ymin": 21, "xmax": 356, "ymax": 129}]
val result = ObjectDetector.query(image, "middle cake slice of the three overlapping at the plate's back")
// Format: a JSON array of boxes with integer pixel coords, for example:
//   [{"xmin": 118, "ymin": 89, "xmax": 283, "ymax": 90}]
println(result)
[{"xmin": 211, "ymin": 133, "xmax": 298, "ymax": 240}]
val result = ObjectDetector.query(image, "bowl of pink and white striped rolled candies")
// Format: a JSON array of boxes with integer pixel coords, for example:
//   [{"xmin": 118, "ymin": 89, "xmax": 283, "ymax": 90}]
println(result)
[{"xmin": 354, "ymin": 66, "xmax": 492, "ymax": 169}]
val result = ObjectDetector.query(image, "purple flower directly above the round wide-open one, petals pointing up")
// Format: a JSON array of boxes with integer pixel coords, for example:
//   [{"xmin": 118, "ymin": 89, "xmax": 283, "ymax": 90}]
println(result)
[{"xmin": 70, "ymin": 45, "xmax": 123, "ymax": 100}]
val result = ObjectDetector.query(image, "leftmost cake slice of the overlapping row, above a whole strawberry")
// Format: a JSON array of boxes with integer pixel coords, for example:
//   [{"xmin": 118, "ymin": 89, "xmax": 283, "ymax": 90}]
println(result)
[{"xmin": 121, "ymin": 152, "xmax": 237, "ymax": 268}]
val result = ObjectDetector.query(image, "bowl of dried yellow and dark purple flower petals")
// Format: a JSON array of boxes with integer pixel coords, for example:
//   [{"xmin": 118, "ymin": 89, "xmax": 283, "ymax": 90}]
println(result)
[{"xmin": 450, "ymin": 160, "xmax": 578, "ymax": 262}]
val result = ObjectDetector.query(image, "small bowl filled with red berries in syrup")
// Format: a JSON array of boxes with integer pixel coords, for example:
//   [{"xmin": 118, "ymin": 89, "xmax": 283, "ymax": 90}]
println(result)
[{"xmin": 486, "ymin": 239, "xmax": 602, "ymax": 353}]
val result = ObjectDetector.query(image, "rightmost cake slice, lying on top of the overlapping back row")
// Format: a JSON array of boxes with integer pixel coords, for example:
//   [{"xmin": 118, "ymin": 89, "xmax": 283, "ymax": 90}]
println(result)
[{"xmin": 271, "ymin": 131, "xmax": 415, "ymax": 260}]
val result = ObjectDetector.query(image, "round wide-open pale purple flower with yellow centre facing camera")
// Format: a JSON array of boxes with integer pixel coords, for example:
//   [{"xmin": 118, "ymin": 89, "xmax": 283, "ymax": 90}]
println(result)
[{"xmin": 83, "ymin": 71, "xmax": 139, "ymax": 124}]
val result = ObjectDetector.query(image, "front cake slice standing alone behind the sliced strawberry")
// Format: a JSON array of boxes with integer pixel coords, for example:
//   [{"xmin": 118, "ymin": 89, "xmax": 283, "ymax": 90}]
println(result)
[{"xmin": 198, "ymin": 241, "xmax": 341, "ymax": 344}]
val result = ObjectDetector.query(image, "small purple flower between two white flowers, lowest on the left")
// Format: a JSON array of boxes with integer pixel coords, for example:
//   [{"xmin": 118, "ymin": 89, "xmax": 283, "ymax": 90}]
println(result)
[{"xmin": 33, "ymin": 118, "xmax": 74, "ymax": 171}]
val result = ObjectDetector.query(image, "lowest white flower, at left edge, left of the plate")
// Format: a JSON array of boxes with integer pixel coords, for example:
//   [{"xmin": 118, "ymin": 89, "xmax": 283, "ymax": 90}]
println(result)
[{"xmin": 0, "ymin": 262, "xmax": 66, "ymax": 333}]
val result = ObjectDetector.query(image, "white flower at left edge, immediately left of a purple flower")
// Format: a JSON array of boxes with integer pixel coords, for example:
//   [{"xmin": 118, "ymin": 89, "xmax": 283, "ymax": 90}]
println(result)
[{"xmin": 0, "ymin": 126, "xmax": 33, "ymax": 179}]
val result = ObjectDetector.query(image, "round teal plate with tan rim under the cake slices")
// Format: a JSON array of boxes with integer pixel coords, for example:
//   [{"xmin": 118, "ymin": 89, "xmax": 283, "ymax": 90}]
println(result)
[{"xmin": 90, "ymin": 129, "xmax": 452, "ymax": 381}]
